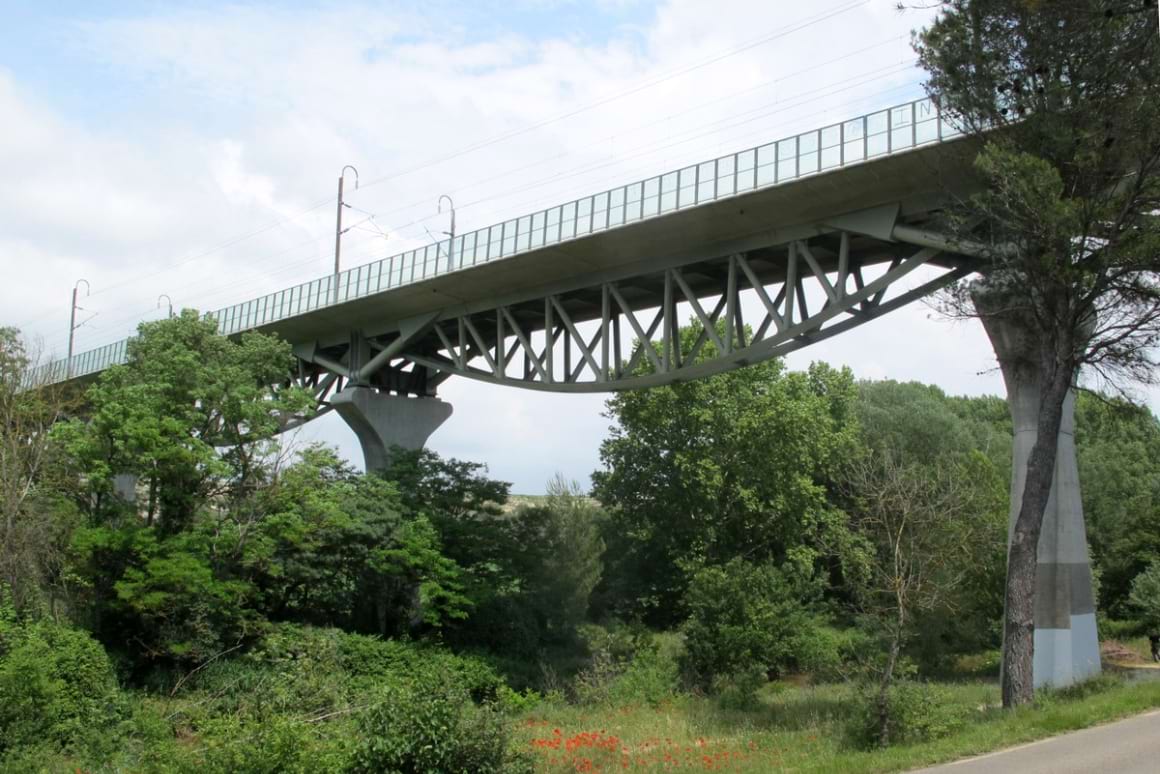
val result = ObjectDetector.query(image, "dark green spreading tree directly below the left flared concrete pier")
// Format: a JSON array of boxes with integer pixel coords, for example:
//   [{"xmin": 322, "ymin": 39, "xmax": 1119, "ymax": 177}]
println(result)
[{"xmin": 242, "ymin": 446, "xmax": 470, "ymax": 636}]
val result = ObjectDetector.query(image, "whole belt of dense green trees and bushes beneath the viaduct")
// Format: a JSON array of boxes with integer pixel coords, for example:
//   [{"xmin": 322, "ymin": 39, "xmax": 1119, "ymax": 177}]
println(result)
[{"xmin": 0, "ymin": 313, "xmax": 1160, "ymax": 772}]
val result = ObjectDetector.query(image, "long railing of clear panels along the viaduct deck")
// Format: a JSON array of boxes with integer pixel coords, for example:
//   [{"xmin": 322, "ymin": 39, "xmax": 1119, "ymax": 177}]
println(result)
[{"xmin": 38, "ymin": 99, "xmax": 962, "ymax": 381}]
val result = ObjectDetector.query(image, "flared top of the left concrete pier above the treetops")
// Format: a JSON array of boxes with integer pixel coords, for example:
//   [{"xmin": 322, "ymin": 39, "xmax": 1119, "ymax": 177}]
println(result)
[{"xmin": 331, "ymin": 386, "xmax": 451, "ymax": 472}]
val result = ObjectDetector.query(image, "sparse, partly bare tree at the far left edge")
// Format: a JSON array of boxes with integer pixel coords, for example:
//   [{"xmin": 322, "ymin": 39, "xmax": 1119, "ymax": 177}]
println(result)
[{"xmin": 0, "ymin": 328, "xmax": 73, "ymax": 612}]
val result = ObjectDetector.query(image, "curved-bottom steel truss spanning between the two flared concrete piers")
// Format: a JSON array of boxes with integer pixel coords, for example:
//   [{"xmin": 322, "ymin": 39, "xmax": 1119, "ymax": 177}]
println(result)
[{"xmin": 371, "ymin": 230, "xmax": 973, "ymax": 395}]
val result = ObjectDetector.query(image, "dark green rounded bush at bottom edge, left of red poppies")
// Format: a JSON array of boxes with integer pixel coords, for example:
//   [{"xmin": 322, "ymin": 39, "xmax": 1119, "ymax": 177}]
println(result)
[{"xmin": 350, "ymin": 670, "xmax": 520, "ymax": 774}]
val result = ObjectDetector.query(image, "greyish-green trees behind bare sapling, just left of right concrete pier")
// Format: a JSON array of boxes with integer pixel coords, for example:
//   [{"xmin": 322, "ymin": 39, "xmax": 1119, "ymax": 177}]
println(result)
[{"xmin": 843, "ymin": 382, "xmax": 1010, "ymax": 668}]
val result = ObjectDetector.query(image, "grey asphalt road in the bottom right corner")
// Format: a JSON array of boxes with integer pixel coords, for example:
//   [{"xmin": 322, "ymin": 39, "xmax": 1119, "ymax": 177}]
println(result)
[{"xmin": 921, "ymin": 711, "xmax": 1160, "ymax": 774}]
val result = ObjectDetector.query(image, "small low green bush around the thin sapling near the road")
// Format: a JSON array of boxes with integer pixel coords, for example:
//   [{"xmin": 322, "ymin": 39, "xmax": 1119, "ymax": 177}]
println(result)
[{"xmin": 850, "ymin": 680, "xmax": 972, "ymax": 748}]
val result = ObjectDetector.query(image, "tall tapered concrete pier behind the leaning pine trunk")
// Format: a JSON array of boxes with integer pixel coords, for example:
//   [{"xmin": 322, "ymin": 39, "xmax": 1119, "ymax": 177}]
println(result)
[{"xmin": 972, "ymin": 287, "xmax": 1100, "ymax": 688}]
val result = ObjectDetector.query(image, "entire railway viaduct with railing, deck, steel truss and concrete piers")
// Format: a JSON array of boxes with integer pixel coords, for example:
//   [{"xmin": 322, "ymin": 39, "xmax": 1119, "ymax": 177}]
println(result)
[{"xmin": 39, "ymin": 100, "xmax": 1100, "ymax": 686}]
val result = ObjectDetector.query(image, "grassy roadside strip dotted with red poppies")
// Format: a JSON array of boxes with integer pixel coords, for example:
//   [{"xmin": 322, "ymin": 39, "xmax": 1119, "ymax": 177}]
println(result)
[{"xmin": 517, "ymin": 677, "xmax": 1160, "ymax": 774}]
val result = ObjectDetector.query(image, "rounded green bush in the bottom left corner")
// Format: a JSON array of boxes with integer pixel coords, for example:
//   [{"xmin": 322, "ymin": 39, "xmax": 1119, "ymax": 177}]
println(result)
[{"xmin": 0, "ymin": 622, "xmax": 124, "ymax": 753}]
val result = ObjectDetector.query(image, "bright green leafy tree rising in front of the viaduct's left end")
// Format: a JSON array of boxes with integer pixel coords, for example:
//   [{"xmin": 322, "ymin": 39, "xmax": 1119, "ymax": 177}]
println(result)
[{"xmin": 58, "ymin": 310, "xmax": 310, "ymax": 533}]
